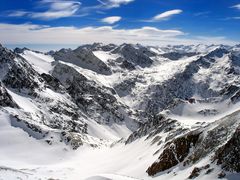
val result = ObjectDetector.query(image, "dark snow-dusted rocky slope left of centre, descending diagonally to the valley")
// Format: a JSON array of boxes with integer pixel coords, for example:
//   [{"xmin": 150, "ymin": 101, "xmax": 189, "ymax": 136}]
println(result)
[{"xmin": 52, "ymin": 63, "xmax": 139, "ymax": 129}]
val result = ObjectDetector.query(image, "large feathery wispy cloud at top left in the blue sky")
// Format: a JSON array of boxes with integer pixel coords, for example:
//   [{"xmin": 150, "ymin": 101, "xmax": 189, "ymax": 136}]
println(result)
[{"xmin": 8, "ymin": 0, "xmax": 81, "ymax": 20}]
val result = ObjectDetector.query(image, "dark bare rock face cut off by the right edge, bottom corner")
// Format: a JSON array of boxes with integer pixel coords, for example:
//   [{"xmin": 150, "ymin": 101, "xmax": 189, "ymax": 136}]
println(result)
[{"xmin": 214, "ymin": 126, "xmax": 240, "ymax": 173}]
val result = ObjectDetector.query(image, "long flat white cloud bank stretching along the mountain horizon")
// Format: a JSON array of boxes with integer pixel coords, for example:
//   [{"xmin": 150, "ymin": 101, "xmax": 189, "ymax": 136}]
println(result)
[{"xmin": 0, "ymin": 24, "xmax": 236, "ymax": 45}]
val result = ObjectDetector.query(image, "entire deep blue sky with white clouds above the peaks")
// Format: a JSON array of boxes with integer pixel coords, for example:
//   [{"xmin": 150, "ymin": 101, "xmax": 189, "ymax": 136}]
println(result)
[{"xmin": 0, "ymin": 0, "xmax": 240, "ymax": 47}]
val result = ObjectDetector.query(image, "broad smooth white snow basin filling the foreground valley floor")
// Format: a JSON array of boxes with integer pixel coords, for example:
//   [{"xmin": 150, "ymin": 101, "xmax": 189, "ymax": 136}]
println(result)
[{"xmin": 0, "ymin": 112, "xmax": 159, "ymax": 180}]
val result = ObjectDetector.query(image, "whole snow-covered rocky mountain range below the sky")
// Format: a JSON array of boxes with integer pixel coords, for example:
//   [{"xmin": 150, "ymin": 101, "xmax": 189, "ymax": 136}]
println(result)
[{"xmin": 0, "ymin": 43, "xmax": 240, "ymax": 180}]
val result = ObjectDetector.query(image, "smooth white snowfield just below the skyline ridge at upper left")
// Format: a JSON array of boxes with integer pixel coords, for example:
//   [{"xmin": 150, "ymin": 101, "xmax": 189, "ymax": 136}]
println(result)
[{"xmin": 21, "ymin": 50, "xmax": 55, "ymax": 74}]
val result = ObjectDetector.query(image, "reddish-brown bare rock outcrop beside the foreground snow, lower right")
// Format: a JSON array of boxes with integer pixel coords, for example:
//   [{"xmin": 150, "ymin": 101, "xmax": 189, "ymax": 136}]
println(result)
[{"xmin": 147, "ymin": 132, "xmax": 200, "ymax": 176}]
